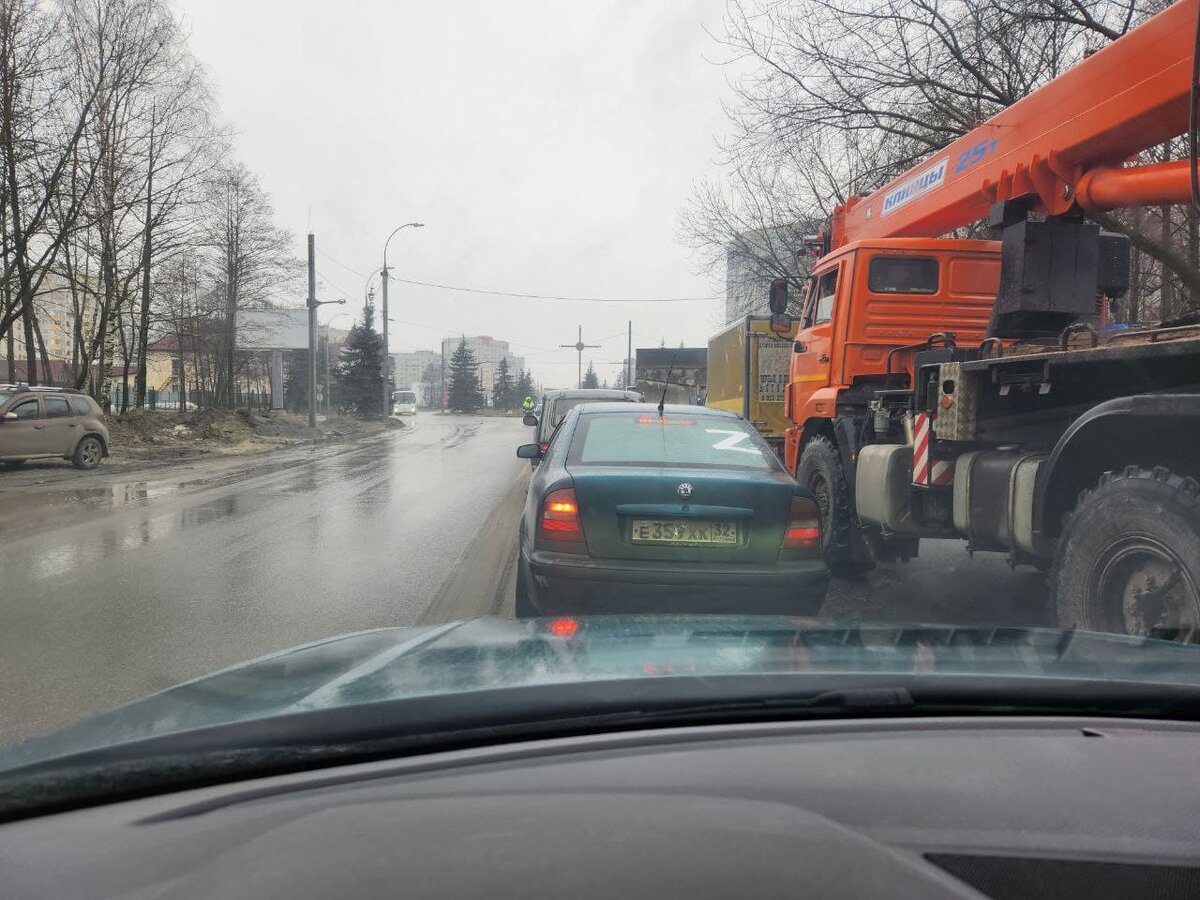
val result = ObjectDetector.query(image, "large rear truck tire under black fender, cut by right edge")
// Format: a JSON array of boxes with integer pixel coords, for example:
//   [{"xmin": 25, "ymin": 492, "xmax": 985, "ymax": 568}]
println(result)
[{"xmin": 1050, "ymin": 466, "xmax": 1200, "ymax": 640}]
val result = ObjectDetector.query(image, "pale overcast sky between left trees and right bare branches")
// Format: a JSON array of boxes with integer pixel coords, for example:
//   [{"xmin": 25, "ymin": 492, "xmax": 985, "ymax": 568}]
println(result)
[{"xmin": 178, "ymin": 0, "xmax": 728, "ymax": 386}]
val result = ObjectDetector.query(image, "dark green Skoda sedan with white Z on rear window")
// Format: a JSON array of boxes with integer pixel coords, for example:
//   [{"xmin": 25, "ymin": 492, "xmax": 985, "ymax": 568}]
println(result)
[{"xmin": 516, "ymin": 403, "xmax": 829, "ymax": 616}]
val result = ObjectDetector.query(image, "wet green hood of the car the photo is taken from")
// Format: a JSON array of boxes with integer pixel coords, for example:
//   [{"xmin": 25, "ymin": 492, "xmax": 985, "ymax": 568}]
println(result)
[{"xmin": 7, "ymin": 616, "xmax": 1200, "ymax": 770}]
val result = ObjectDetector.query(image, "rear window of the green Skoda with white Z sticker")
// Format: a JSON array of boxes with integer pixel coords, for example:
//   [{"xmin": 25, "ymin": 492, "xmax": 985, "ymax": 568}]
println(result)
[{"xmin": 568, "ymin": 413, "xmax": 772, "ymax": 469}]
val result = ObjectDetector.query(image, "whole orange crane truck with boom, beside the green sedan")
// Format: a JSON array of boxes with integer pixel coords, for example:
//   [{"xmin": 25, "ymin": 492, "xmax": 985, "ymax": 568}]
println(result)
[{"xmin": 772, "ymin": 0, "xmax": 1200, "ymax": 640}]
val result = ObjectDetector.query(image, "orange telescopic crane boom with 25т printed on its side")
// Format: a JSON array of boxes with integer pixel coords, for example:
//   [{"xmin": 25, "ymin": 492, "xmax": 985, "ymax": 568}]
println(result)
[{"xmin": 832, "ymin": 0, "xmax": 1200, "ymax": 248}]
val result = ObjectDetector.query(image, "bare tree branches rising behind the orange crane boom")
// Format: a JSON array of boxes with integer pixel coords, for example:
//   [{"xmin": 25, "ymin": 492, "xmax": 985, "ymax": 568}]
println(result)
[{"xmin": 682, "ymin": 0, "xmax": 1200, "ymax": 321}]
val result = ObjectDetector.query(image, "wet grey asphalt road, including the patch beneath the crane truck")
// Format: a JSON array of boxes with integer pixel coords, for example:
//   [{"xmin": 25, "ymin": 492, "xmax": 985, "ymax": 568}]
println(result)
[{"xmin": 0, "ymin": 414, "xmax": 1050, "ymax": 744}]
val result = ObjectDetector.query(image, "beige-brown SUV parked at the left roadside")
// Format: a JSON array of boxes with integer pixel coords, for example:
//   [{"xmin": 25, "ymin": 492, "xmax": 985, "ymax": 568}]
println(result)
[{"xmin": 0, "ymin": 384, "xmax": 108, "ymax": 469}]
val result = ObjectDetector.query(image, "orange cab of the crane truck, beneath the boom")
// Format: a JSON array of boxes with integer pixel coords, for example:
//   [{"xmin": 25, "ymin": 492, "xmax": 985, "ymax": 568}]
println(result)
[{"xmin": 785, "ymin": 238, "xmax": 1000, "ymax": 474}]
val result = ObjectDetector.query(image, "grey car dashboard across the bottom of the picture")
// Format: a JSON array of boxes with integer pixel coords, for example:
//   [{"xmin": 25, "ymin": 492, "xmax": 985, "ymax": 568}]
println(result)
[{"xmin": 0, "ymin": 718, "xmax": 1200, "ymax": 900}]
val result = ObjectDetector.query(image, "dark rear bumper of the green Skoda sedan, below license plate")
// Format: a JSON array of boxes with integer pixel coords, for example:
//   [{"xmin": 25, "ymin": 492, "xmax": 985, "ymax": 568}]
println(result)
[{"xmin": 521, "ymin": 550, "xmax": 829, "ymax": 616}]
